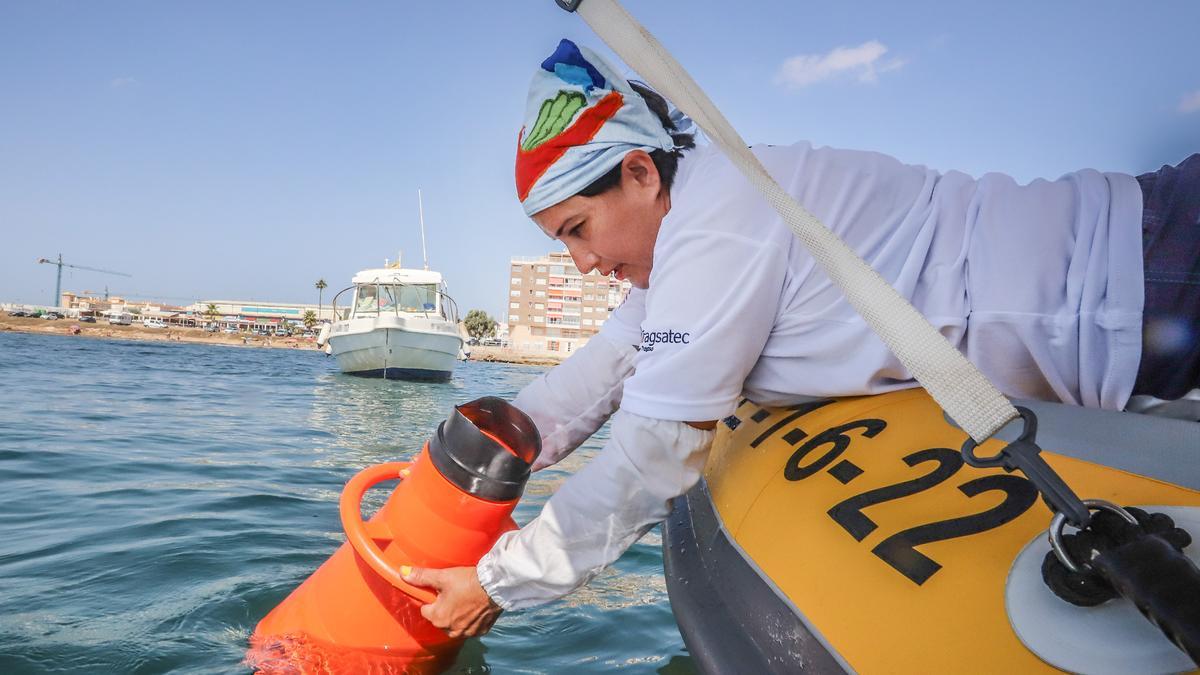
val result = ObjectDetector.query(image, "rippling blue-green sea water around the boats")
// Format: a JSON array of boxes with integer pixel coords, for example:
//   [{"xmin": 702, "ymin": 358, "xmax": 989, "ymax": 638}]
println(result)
[{"xmin": 0, "ymin": 333, "xmax": 694, "ymax": 675}]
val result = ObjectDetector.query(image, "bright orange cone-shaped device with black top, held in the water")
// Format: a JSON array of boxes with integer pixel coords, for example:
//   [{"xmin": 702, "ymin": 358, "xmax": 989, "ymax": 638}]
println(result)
[{"xmin": 246, "ymin": 396, "xmax": 541, "ymax": 674}]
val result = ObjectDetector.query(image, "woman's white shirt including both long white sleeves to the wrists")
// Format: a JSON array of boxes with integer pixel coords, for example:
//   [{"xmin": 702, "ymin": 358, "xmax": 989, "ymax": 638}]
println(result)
[{"xmin": 479, "ymin": 143, "xmax": 1142, "ymax": 609}]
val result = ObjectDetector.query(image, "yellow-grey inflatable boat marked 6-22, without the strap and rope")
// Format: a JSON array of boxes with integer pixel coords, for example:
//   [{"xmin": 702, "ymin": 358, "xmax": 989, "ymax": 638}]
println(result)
[{"xmin": 662, "ymin": 389, "xmax": 1200, "ymax": 673}]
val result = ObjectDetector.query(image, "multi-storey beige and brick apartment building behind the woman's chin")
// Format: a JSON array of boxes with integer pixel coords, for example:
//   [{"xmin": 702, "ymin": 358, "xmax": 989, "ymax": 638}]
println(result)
[{"xmin": 508, "ymin": 251, "xmax": 630, "ymax": 356}]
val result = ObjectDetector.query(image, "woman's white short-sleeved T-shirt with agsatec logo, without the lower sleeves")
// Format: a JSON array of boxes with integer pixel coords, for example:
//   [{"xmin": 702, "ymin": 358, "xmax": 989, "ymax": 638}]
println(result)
[{"xmin": 612, "ymin": 143, "xmax": 1144, "ymax": 420}]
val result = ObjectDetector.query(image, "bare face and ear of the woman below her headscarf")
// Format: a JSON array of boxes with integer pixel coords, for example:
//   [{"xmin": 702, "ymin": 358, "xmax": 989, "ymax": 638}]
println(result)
[{"xmin": 533, "ymin": 150, "xmax": 671, "ymax": 288}]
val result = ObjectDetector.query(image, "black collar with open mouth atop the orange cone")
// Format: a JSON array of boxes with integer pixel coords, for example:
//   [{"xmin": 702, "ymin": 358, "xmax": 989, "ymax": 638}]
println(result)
[{"xmin": 430, "ymin": 396, "xmax": 541, "ymax": 502}]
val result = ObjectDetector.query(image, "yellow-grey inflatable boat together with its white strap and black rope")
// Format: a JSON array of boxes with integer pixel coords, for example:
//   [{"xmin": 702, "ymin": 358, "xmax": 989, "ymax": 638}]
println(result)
[{"xmin": 544, "ymin": 0, "xmax": 1200, "ymax": 673}]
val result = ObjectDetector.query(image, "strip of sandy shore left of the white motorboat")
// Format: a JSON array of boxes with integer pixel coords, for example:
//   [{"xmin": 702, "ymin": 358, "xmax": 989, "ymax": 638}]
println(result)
[{"xmin": 0, "ymin": 313, "xmax": 317, "ymax": 350}]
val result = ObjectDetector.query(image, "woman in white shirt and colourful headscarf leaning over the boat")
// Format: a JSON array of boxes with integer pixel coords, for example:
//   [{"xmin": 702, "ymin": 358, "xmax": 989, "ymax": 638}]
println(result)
[{"xmin": 409, "ymin": 40, "xmax": 1200, "ymax": 637}]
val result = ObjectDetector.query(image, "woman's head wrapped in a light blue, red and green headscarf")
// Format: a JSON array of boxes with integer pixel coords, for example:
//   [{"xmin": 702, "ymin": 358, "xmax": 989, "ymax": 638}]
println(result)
[{"xmin": 516, "ymin": 40, "xmax": 695, "ymax": 288}]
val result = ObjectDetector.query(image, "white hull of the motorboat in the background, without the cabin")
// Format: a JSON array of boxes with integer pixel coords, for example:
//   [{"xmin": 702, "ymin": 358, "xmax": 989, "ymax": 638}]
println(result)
[{"xmin": 329, "ymin": 318, "xmax": 462, "ymax": 382}]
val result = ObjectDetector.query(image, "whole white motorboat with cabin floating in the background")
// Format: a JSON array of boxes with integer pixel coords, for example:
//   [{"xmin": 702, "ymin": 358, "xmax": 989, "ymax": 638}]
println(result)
[{"xmin": 317, "ymin": 264, "xmax": 463, "ymax": 382}]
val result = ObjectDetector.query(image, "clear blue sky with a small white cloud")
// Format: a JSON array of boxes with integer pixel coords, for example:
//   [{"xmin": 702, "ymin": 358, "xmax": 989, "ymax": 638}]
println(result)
[{"xmin": 0, "ymin": 0, "xmax": 1200, "ymax": 315}]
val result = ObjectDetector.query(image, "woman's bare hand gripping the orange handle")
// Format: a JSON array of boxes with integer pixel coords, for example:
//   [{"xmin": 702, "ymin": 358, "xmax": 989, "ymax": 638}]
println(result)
[{"xmin": 404, "ymin": 567, "xmax": 503, "ymax": 638}]
